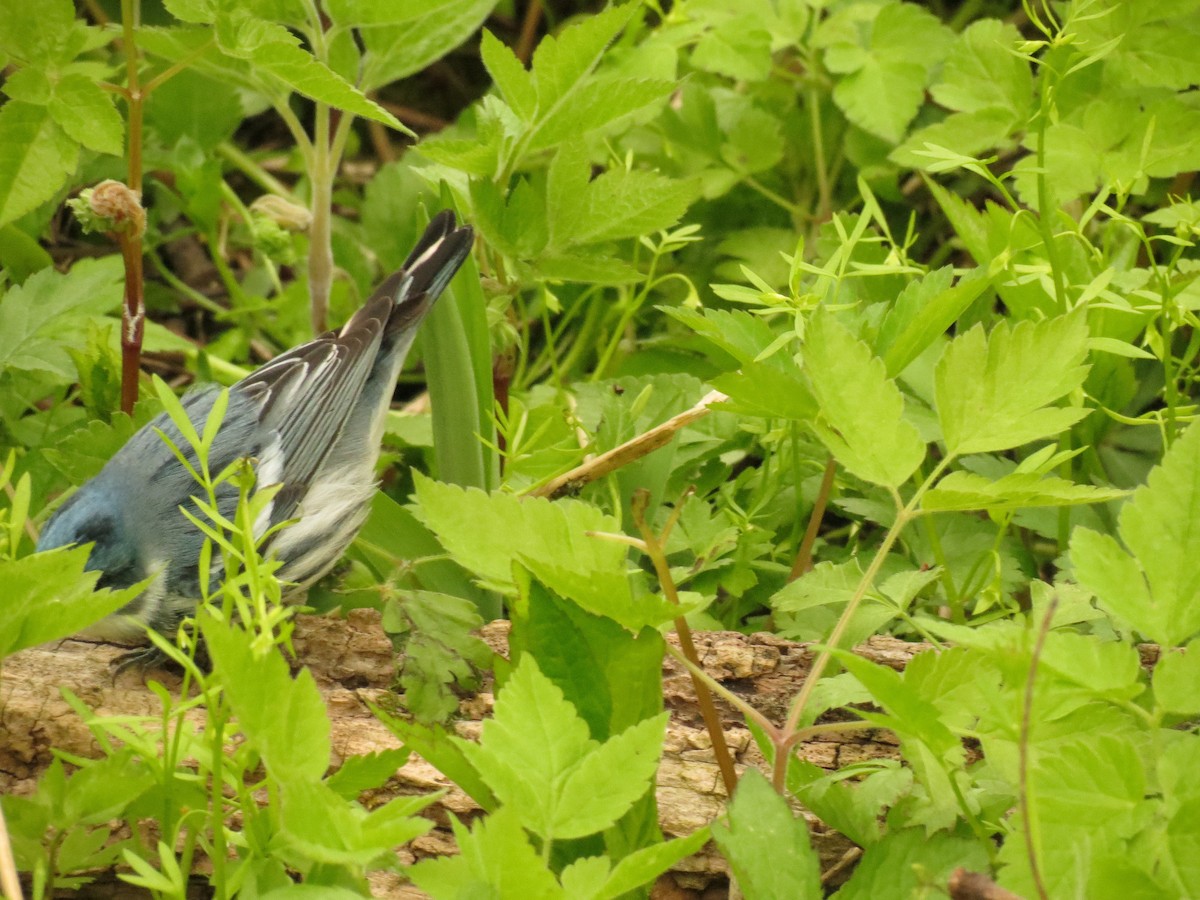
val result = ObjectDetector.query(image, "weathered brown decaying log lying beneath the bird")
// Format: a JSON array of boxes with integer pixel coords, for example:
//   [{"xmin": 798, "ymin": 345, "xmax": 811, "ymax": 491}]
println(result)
[{"xmin": 0, "ymin": 610, "xmax": 922, "ymax": 898}]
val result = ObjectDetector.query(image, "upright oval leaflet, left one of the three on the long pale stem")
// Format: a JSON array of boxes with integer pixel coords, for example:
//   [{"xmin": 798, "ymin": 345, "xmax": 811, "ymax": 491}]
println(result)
[{"xmin": 804, "ymin": 311, "xmax": 925, "ymax": 487}]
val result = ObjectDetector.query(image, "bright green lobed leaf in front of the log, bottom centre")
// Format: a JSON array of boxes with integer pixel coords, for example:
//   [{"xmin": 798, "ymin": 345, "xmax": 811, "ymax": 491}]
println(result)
[{"xmin": 457, "ymin": 656, "xmax": 666, "ymax": 840}]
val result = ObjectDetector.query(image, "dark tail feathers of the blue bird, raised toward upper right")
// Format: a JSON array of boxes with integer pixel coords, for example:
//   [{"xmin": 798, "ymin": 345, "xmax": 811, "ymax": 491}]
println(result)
[{"xmin": 360, "ymin": 210, "xmax": 475, "ymax": 342}]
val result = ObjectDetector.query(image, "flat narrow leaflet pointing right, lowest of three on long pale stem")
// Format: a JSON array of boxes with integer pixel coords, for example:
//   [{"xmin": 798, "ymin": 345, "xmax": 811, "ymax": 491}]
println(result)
[{"xmin": 920, "ymin": 472, "xmax": 1127, "ymax": 512}]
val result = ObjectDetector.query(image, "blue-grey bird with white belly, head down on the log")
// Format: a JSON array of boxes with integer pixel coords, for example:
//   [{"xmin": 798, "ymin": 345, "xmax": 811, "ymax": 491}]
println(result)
[{"xmin": 37, "ymin": 211, "xmax": 473, "ymax": 642}]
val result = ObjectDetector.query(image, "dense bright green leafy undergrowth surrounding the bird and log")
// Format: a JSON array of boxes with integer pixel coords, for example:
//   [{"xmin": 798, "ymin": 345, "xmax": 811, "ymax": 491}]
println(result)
[{"xmin": 0, "ymin": 0, "xmax": 1200, "ymax": 899}]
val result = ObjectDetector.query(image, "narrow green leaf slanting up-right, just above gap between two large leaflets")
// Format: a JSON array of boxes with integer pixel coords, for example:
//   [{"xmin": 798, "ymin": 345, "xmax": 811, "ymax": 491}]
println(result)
[{"xmin": 875, "ymin": 265, "xmax": 989, "ymax": 378}]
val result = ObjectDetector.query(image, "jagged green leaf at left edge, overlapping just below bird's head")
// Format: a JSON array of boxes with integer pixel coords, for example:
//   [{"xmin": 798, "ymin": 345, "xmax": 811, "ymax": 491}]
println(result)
[{"xmin": 0, "ymin": 546, "xmax": 145, "ymax": 660}]
